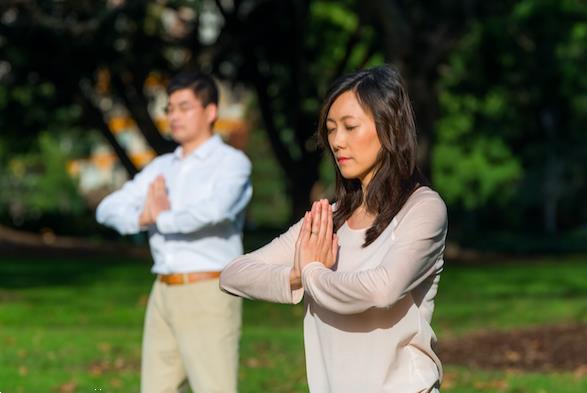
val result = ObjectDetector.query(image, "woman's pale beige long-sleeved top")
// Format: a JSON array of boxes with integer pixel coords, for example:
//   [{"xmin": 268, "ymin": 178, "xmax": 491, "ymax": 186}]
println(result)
[{"xmin": 220, "ymin": 187, "xmax": 447, "ymax": 393}]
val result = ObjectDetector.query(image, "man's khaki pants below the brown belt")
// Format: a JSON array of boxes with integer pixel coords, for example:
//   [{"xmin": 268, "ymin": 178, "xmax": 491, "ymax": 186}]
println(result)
[{"xmin": 141, "ymin": 279, "xmax": 242, "ymax": 393}]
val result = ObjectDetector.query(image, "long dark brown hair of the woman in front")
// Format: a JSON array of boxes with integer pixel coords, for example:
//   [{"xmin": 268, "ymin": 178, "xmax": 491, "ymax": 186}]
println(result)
[{"xmin": 318, "ymin": 65, "xmax": 425, "ymax": 247}]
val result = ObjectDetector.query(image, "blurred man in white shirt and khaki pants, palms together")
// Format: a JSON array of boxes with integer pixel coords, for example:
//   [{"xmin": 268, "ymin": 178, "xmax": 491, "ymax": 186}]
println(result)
[{"xmin": 96, "ymin": 73, "xmax": 252, "ymax": 393}]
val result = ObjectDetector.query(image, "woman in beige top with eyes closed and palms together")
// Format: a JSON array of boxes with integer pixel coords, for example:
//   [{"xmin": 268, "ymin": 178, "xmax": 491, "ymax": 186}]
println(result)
[{"xmin": 221, "ymin": 66, "xmax": 447, "ymax": 393}]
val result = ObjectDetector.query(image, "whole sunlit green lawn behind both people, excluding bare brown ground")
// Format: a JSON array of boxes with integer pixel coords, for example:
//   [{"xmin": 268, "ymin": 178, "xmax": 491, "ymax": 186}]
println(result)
[{"xmin": 0, "ymin": 256, "xmax": 587, "ymax": 393}]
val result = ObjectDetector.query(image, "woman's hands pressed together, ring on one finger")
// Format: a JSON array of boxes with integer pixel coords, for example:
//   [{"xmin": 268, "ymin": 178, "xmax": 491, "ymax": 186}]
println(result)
[{"xmin": 290, "ymin": 199, "xmax": 338, "ymax": 289}]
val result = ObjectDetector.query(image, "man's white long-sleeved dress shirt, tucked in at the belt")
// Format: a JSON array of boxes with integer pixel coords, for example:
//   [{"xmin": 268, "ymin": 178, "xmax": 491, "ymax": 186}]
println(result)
[{"xmin": 96, "ymin": 135, "xmax": 252, "ymax": 274}]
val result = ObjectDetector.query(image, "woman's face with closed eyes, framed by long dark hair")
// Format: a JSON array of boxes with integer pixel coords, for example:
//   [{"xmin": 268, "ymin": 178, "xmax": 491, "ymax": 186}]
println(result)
[{"xmin": 326, "ymin": 91, "xmax": 381, "ymax": 186}]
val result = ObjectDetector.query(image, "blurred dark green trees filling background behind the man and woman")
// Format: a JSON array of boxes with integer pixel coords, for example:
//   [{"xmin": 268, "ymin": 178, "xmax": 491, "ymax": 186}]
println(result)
[{"xmin": 0, "ymin": 0, "xmax": 587, "ymax": 248}]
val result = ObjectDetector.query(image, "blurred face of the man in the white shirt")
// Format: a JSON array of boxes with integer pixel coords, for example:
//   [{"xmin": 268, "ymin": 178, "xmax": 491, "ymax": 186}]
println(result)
[{"xmin": 167, "ymin": 88, "xmax": 217, "ymax": 145}]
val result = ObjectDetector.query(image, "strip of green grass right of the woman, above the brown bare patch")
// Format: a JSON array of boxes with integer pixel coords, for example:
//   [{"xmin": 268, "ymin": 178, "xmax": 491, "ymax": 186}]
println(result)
[{"xmin": 434, "ymin": 256, "xmax": 587, "ymax": 336}]
